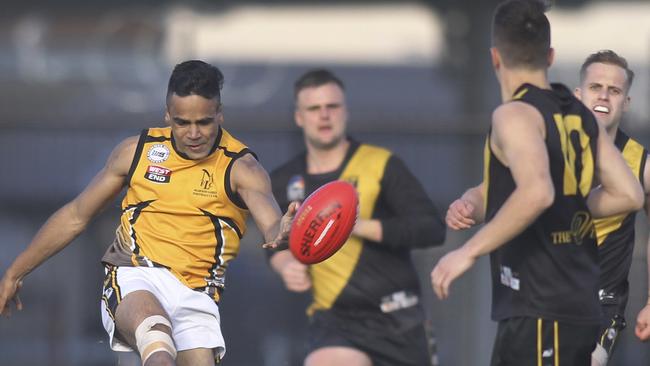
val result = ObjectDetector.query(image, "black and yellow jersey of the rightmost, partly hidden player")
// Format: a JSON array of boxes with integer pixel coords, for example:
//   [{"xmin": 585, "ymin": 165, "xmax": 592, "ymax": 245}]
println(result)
[{"xmin": 594, "ymin": 129, "xmax": 648, "ymax": 309}]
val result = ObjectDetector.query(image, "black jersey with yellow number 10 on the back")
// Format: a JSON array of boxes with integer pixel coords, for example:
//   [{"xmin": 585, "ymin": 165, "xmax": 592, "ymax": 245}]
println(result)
[{"xmin": 484, "ymin": 84, "xmax": 600, "ymax": 324}]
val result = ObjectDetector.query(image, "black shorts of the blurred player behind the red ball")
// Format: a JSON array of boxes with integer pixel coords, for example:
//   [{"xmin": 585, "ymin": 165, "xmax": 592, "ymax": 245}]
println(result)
[{"xmin": 308, "ymin": 311, "xmax": 437, "ymax": 366}]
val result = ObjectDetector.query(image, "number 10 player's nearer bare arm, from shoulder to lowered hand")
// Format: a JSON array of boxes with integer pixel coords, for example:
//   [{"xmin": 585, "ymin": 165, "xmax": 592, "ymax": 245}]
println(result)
[{"xmin": 431, "ymin": 102, "xmax": 555, "ymax": 299}]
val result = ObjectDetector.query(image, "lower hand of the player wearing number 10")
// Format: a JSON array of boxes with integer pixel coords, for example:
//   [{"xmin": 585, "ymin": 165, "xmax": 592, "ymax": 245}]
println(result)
[{"xmin": 431, "ymin": 247, "xmax": 476, "ymax": 300}]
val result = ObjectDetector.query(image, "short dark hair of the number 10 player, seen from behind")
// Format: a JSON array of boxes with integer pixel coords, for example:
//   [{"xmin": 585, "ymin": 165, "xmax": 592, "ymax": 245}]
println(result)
[{"xmin": 492, "ymin": 0, "xmax": 551, "ymax": 70}]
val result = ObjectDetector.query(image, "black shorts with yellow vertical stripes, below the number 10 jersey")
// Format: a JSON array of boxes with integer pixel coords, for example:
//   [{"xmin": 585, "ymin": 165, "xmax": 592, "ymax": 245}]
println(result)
[{"xmin": 491, "ymin": 317, "xmax": 598, "ymax": 366}]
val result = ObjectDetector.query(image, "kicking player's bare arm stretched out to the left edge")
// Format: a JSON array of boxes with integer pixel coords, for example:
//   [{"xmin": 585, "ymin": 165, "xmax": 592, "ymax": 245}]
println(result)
[{"xmin": 0, "ymin": 137, "xmax": 138, "ymax": 314}]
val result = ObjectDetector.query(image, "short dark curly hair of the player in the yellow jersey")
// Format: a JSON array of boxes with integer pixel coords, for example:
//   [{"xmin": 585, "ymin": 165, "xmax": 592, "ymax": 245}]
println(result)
[{"xmin": 167, "ymin": 60, "xmax": 223, "ymax": 102}]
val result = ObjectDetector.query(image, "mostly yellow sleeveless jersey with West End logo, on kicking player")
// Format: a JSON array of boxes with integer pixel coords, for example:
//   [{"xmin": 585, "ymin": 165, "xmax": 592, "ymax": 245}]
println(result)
[{"xmin": 102, "ymin": 127, "xmax": 252, "ymax": 300}]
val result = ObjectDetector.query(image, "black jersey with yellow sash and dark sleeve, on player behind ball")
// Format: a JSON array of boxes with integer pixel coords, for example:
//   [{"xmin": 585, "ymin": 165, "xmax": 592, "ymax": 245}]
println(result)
[{"xmin": 271, "ymin": 141, "xmax": 445, "ymax": 332}]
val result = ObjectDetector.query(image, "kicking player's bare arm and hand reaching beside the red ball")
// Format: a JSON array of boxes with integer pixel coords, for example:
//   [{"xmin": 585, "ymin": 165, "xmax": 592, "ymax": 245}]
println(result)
[{"xmin": 230, "ymin": 154, "xmax": 297, "ymax": 248}]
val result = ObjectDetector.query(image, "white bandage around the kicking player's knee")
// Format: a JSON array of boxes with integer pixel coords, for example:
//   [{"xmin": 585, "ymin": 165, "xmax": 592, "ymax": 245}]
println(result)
[{"xmin": 135, "ymin": 315, "xmax": 176, "ymax": 365}]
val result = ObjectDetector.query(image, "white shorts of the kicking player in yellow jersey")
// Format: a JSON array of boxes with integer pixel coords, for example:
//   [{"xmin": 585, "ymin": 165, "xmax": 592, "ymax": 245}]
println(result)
[{"xmin": 101, "ymin": 267, "xmax": 226, "ymax": 358}]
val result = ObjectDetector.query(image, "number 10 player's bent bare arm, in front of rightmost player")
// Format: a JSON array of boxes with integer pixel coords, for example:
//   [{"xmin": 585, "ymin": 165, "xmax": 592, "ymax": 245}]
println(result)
[{"xmin": 587, "ymin": 124, "xmax": 644, "ymax": 218}]
